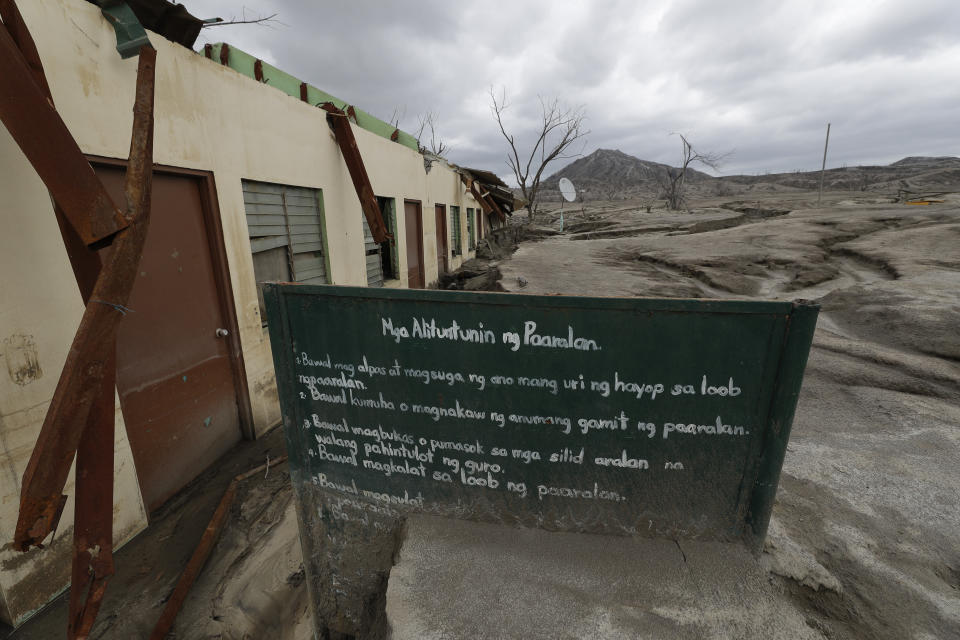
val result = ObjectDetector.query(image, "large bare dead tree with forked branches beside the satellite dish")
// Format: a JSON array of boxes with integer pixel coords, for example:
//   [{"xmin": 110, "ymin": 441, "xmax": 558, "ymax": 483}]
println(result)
[{"xmin": 490, "ymin": 87, "xmax": 590, "ymax": 221}]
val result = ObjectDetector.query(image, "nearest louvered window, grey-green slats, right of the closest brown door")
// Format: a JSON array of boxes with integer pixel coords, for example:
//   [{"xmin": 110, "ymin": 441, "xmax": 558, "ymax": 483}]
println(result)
[{"xmin": 242, "ymin": 180, "xmax": 329, "ymax": 324}]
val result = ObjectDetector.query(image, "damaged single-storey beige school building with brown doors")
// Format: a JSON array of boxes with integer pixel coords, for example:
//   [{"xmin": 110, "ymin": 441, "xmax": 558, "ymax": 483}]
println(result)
[{"xmin": 0, "ymin": 0, "xmax": 514, "ymax": 626}]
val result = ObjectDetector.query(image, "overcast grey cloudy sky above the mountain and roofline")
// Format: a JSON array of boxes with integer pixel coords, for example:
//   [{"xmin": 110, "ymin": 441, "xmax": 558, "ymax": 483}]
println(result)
[{"xmin": 191, "ymin": 0, "xmax": 960, "ymax": 183}]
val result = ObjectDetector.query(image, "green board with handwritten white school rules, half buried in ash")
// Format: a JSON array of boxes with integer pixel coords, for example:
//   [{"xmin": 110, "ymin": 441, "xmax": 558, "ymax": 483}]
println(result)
[{"xmin": 265, "ymin": 285, "xmax": 818, "ymax": 636}]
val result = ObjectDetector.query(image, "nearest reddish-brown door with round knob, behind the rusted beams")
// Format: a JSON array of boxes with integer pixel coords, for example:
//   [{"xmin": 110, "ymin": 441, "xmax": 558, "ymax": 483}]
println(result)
[{"xmin": 96, "ymin": 166, "xmax": 241, "ymax": 511}]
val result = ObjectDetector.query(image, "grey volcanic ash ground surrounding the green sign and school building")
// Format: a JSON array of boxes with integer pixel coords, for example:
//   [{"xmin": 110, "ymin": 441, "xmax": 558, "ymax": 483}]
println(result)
[{"xmin": 9, "ymin": 191, "xmax": 960, "ymax": 640}]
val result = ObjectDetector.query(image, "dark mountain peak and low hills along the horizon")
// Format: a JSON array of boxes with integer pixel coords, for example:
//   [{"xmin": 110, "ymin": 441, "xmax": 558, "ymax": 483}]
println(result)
[{"xmin": 541, "ymin": 149, "xmax": 960, "ymax": 202}]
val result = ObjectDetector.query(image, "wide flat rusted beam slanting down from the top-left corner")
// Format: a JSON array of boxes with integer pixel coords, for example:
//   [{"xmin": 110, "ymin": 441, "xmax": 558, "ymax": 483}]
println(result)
[{"xmin": 0, "ymin": 15, "xmax": 127, "ymax": 245}]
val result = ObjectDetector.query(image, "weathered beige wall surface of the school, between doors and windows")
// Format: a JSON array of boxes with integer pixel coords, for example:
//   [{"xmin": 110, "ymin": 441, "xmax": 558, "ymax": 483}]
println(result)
[{"xmin": 0, "ymin": 0, "xmax": 478, "ymax": 620}]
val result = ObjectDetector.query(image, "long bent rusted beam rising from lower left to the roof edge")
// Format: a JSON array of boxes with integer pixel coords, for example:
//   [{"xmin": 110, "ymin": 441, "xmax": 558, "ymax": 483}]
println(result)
[{"xmin": 14, "ymin": 46, "xmax": 156, "ymax": 551}]
